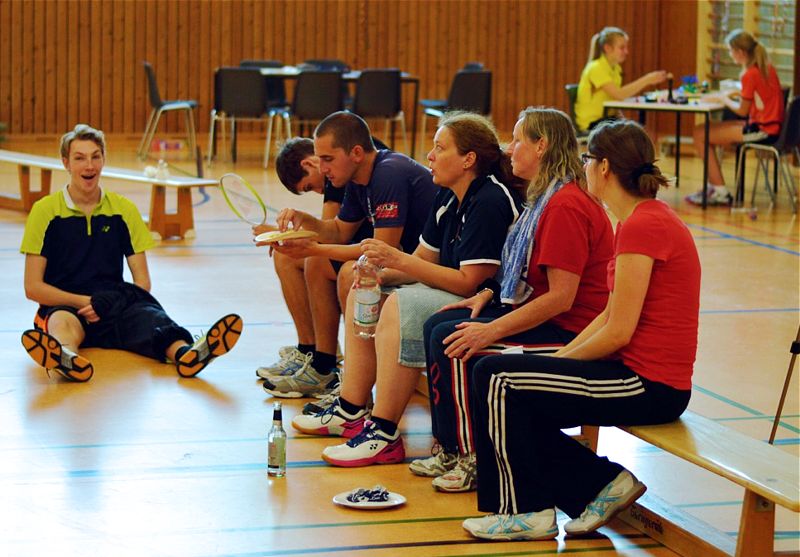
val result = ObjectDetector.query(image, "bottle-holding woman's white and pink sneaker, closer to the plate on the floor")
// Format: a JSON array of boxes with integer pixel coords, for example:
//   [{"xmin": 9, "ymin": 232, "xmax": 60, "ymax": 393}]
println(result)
[{"xmin": 322, "ymin": 420, "xmax": 406, "ymax": 467}]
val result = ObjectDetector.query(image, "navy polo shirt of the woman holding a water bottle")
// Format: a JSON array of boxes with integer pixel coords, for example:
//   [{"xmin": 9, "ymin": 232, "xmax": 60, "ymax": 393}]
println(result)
[{"xmin": 419, "ymin": 175, "xmax": 522, "ymax": 269}]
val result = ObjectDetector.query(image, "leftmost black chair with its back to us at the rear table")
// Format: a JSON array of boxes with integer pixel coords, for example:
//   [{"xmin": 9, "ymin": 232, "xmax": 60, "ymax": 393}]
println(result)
[{"xmin": 208, "ymin": 67, "xmax": 278, "ymax": 164}]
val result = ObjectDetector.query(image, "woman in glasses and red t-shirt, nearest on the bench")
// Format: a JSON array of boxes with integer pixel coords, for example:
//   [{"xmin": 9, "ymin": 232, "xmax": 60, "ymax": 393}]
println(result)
[{"xmin": 463, "ymin": 120, "xmax": 700, "ymax": 540}]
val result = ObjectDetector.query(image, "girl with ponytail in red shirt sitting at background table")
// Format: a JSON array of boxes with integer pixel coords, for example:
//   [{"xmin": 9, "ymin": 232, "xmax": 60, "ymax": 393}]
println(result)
[{"xmin": 686, "ymin": 29, "xmax": 786, "ymax": 205}]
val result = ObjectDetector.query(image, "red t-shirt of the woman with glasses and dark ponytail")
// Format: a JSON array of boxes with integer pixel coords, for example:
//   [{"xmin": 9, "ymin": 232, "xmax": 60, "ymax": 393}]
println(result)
[{"xmin": 608, "ymin": 199, "xmax": 700, "ymax": 390}]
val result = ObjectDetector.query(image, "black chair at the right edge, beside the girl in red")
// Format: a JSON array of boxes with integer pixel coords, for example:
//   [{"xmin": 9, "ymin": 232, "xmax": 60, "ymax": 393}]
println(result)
[{"xmin": 736, "ymin": 96, "xmax": 800, "ymax": 213}]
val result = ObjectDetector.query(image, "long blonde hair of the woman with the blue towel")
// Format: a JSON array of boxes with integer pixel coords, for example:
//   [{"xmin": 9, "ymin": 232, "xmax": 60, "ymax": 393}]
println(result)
[{"xmin": 519, "ymin": 106, "xmax": 586, "ymax": 203}]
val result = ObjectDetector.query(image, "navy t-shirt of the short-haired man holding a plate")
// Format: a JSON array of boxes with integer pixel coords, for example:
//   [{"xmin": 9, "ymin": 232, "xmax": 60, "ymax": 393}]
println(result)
[{"xmin": 338, "ymin": 150, "xmax": 438, "ymax": 253}]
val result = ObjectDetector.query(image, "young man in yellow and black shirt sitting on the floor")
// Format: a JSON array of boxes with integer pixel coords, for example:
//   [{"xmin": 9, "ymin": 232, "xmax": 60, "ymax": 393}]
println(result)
[{"xmin": 20, "ymin": 124, "xmax": 242, "ymax": 382}]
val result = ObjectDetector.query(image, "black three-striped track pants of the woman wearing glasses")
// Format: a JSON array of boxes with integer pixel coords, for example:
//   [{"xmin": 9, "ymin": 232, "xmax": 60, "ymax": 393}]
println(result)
[{"xmin": 470, "ymin": 355, "xmax": 691, "ymax": 517}]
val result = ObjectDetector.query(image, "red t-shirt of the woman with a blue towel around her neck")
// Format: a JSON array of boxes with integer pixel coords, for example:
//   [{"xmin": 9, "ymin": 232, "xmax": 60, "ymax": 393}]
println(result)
[{"xmin": 527, "ymin": 182, "xmax": 614, "ymax": 333}]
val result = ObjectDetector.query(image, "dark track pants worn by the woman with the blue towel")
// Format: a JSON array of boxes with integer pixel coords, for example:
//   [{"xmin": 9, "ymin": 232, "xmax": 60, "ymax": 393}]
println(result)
[{"xmin": 425, "ymin": 306, "xmax": 575, "ymax": 454}]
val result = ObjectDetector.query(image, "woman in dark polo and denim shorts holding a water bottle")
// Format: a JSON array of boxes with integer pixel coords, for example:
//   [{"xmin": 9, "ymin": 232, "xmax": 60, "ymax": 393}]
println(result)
[{"xmin": 292, "ymin": 113, "xmax": 520, "ymax": 466}]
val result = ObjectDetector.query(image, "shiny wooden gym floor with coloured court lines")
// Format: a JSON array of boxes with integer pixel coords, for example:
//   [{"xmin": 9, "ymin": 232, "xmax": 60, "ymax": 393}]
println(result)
[{"xmin": 0, "ymin": 132, "xmax": 800, "ymax": 557}]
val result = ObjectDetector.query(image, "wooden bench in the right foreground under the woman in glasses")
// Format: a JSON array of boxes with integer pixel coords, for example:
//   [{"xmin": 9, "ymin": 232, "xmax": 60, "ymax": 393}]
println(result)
[{"xmin": 619, "ymin": 411, "xmax": 800, "ymax": 557}]
